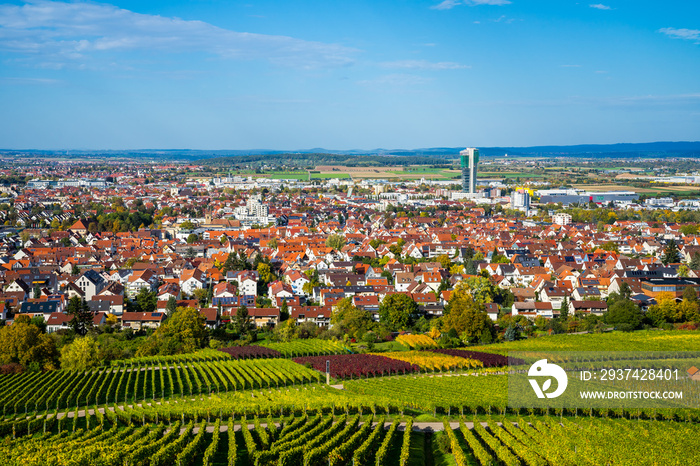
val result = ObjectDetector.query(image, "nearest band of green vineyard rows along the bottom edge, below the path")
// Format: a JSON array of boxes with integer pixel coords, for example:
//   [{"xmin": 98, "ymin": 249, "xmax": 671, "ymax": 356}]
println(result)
[{"xmin": 0, "ymin": 408, "xmax": 700, "ymax": 466}]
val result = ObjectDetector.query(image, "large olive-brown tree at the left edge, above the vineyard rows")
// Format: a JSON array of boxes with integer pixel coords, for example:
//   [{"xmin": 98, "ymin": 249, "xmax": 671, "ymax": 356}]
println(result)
[{"xmin": 0, "ymin": 316, "xmax": 57, "ymax": 370}]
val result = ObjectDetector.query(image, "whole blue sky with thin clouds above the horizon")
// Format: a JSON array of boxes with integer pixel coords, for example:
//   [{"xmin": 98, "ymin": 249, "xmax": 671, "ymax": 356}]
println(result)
[{"xmin": 0, "ymin": 0, "xmax": 700, "ymax": 150}]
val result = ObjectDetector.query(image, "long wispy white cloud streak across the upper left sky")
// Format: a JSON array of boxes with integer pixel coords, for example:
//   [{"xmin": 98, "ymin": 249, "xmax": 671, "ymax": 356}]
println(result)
[{"xmin": 0, "ymin": 0, "xmax": 357, "ymax": 68}]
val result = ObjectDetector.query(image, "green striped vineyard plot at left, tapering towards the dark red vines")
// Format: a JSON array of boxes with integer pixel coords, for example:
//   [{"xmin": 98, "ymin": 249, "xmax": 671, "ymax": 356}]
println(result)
[{"xmin": 0, "ymin": 353, "xmax": 320, "ymax": 414}]
